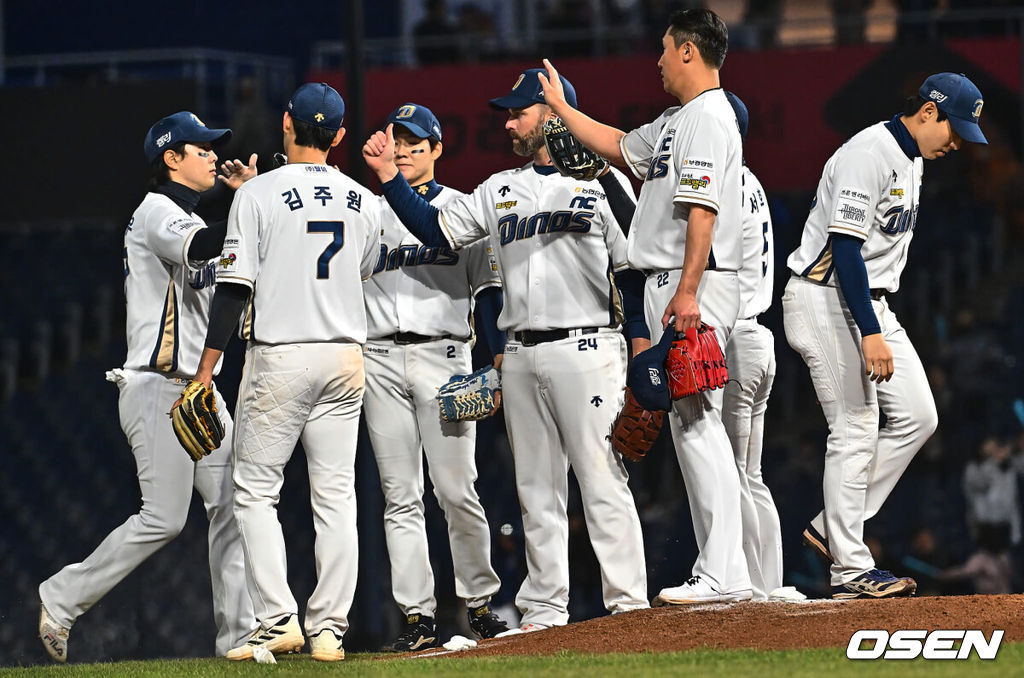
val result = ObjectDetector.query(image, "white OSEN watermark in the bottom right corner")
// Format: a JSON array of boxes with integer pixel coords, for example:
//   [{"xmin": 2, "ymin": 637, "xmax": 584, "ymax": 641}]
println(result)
[{"xmin": 846, "ymin": 629, "xmax": 1004, "ymax": 660}]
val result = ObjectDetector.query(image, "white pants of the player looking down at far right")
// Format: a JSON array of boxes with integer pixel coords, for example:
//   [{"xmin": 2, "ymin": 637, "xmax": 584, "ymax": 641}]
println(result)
[{"xmin": 782, "ymin": 277, "xmax": 938, "ymax": 586}]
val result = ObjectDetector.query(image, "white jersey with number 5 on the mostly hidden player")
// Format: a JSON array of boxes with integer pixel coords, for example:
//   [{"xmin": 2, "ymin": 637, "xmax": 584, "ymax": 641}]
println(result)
[{"xmin": 739, "ymin": 165, "xmax": 775, "ymax": 317}]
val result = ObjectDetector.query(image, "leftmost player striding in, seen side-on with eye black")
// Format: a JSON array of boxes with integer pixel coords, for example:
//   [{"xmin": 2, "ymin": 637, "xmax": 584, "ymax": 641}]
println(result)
[{"xmin": 39, "ymin": 111, "xmax": 256, "ymax": 662}]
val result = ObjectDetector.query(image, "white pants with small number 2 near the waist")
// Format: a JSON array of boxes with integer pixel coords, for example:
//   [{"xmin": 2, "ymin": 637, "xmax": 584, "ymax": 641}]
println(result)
[{"xmin": 364, "ymin": 339, "xmax": 501, "ymax": 617}]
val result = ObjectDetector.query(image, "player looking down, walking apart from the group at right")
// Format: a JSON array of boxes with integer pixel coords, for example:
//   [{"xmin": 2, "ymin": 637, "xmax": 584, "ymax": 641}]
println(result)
[{"xmin": 782, "ymin": 73, "xmax": 987, "ymax": 599}]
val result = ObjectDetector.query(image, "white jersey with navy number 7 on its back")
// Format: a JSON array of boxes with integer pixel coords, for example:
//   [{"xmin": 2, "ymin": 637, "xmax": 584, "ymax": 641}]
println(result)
[{"xmin": 218, "ymin": 163, "xmax": 382, "ymax": 344}]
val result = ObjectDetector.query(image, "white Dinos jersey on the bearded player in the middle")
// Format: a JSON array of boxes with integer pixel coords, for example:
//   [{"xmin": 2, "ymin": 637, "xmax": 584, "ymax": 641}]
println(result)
[{"xmin": 439, "ymin": 163, "xmax": 633, "ymax": 332}]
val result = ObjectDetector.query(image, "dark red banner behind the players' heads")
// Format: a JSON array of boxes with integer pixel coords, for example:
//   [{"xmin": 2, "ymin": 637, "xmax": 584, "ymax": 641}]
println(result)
[{"xmin": 309, "ymin": 39, "xmax": 1021, "ymax": 196}]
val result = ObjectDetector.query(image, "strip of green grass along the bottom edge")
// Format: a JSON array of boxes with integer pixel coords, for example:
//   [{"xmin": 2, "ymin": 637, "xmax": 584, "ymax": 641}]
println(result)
[{"xmin": 6, "ymin": 643, "xmax": 1024, "ymax": 678}]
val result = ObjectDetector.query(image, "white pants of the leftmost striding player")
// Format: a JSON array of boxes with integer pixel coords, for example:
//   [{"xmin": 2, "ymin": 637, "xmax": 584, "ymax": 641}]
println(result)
[{"xmin": 39, "ymin": 370, "xmax": 256, "ymax": 655}]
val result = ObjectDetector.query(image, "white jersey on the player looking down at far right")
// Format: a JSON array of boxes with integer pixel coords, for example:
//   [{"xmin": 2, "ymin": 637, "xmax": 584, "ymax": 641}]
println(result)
[{"xmin": 787, "ymin": 123, "xmax": 924, "ymax": 292}]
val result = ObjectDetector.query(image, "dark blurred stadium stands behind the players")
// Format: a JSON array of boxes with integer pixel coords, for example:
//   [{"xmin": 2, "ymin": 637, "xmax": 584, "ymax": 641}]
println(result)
[{"xmin": 0, "ymin": 0, "xmax": 1024, "ymax": 666}]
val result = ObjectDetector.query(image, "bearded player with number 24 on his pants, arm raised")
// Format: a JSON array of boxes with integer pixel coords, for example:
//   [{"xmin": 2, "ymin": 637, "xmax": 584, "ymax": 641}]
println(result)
[{"xmin": 364, "ymin": 69, "xmax": 647, "ymax": 633}]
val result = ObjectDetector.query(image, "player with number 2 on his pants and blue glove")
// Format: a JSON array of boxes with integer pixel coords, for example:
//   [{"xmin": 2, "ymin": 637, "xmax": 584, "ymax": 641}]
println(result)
[{"xmin": 362, "ymin": 103, "xmax": 508, "ymax": 651}]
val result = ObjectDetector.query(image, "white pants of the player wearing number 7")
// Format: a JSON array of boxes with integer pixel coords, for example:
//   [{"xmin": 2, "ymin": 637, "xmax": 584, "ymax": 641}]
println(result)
[{"xmin": 234, "ymin": 343, "xmax": 364, "ymax": 637}]
